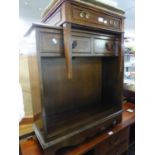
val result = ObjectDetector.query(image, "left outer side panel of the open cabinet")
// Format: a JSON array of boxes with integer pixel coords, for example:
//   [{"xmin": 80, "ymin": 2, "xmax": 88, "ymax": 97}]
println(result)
[{"xmin": 27, "ymin": 30, "xmax": 43, "ymax": 134}]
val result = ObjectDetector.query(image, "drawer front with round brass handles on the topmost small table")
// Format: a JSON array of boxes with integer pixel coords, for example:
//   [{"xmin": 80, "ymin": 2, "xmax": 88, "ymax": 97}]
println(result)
[{"xmin": 72, "ymin": 6, "xmax": 121, "ymax": 30}]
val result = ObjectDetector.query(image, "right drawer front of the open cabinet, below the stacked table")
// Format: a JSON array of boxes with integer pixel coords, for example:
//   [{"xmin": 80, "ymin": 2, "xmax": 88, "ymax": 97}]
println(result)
[{"xmin": 93, "ymin": 38, "xmax": 117, "ymax": 55}]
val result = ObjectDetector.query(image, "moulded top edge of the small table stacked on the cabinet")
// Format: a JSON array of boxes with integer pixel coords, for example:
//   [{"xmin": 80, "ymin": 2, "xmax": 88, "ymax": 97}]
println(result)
[{"xmin": 42, "ymin": 0, "xmax": 125, "ymax": 22}]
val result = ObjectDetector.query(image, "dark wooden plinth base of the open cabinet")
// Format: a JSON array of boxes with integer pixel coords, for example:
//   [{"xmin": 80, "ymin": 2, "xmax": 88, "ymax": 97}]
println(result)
[{"xmin": 33, "ymin": 110, "xmax": 123, "ymax": 155}]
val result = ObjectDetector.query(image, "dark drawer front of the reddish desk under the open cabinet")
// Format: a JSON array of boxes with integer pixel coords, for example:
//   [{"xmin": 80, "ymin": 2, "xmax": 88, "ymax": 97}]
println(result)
[{"xmin": 95, "ymin": 128, "xmax": 129, "ymax": 155}]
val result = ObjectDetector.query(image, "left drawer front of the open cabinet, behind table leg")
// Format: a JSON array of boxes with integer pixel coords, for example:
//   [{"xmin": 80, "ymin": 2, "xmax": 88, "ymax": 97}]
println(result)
[{"xmin": 40, "ymin": 32, "xmax": 63, "ymax": 53}]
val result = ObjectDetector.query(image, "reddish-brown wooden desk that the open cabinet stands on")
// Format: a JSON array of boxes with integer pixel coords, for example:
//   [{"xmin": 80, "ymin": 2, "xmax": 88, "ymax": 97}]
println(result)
[{"xmin": 20, "ymin": 103, "xmax": 135, "ymax": 155}]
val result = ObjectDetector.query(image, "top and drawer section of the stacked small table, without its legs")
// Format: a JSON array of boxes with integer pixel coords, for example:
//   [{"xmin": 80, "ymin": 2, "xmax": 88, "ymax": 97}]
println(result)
[{"xmin": 42, "ymin": 0, "xmax": 124, "ymax": 32}]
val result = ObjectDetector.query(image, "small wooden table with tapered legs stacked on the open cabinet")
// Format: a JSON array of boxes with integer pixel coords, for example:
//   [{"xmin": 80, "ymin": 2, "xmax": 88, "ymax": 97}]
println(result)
[{"xmin": 42, "ymin": 0, "xmax": 124, "ymax": 79}]
